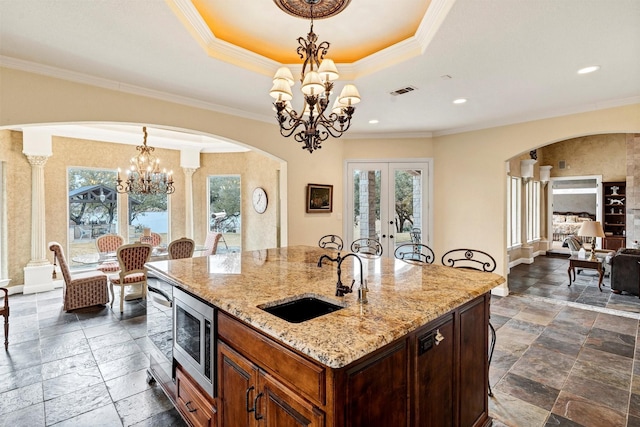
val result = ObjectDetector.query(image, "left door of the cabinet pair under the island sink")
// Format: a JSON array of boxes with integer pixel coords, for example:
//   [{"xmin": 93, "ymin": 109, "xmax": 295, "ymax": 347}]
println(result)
[{"xmin": 218, "ymin": 341, "xmax": 258, "ymax": 427}]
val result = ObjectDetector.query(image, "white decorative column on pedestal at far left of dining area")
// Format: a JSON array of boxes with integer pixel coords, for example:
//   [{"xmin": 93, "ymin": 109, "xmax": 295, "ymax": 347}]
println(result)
[{"xmin": 23, "ymin": 154, "xmax": 54, "ymax": 294}]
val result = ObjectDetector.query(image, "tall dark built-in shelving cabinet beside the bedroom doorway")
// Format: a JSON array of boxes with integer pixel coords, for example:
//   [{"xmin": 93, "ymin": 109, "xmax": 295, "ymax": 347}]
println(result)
[{"xmin": 602, "ymin": 181, "xmax": 627, "ymax": 250}]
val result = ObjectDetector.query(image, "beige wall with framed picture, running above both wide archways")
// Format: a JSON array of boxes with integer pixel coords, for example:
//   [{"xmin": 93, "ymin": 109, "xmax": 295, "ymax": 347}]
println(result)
[{"xmin": 0, "ymin": 69, "xmax": 640, "ymax": 290}]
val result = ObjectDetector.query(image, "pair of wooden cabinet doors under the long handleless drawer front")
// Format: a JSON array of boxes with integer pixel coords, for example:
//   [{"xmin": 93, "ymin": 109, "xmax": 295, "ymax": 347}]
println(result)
[{"xmin": 218, "ymin": 342, "xmax": 324, "ymax": 427}]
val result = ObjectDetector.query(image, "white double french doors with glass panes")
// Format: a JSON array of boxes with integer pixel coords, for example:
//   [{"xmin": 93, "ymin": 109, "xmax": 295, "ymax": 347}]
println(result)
[{"xmin": 345, "ymin": 160, "xmax": 432, "ymax": 257}]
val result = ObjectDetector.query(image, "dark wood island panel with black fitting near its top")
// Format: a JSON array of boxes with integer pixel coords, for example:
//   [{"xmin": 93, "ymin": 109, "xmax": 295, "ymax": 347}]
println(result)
[{"xmin": 414, "ymin": 315, "xmax": 456, "ymax": 427}]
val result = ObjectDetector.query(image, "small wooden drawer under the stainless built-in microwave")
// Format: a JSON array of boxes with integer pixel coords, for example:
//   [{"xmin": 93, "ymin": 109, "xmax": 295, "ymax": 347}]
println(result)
[{"xmin": 176, "ymin": 369, "xmax": 216, "ymax": 427}]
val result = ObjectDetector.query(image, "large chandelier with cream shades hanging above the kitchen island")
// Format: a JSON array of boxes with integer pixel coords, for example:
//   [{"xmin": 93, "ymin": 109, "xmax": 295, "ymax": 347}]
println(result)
[{"xmin": 269, "ymin": 0, "xmax": 360, "ymax": 153}]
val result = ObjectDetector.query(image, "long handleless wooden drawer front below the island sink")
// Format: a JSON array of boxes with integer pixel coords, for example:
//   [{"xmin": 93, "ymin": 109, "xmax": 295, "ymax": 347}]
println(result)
[{"xmin": 218, "ymin": 312, "xmax": 326, "ymax": 406}]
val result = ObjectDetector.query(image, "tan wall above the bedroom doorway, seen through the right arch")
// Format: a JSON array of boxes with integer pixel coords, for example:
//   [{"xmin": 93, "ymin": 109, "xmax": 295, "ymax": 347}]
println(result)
[{"xmin": 538, "ymin": 133, "xmax": 627, "ymax": 182}]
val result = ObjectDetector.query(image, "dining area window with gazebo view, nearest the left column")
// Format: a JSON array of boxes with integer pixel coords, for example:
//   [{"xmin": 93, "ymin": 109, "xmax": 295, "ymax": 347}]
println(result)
[{"xmin": 68, "ymin": 168, "xmax": 118, "ymax": 265}]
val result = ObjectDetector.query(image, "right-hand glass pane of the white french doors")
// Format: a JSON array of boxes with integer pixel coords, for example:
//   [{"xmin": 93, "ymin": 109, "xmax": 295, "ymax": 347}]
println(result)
[{"xmin": 393, "ymin": 169, "xmax": 423, "ymax": 247}]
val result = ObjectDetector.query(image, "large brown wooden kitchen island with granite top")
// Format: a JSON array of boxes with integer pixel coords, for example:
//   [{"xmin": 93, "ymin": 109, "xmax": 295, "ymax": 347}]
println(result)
[{"xmin": 148, "ymin": 246, "xmax": 504, "ymax": 426}]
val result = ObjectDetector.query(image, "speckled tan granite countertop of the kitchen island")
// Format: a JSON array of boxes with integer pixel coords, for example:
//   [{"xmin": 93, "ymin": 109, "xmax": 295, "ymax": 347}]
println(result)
[{"xmin": 147, "ymin": 246, "xmax": 504, "ymax": 368}]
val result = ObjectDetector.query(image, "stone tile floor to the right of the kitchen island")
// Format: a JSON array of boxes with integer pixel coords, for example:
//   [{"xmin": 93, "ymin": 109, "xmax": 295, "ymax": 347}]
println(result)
[{"xmin": 489, "ymin": 256, "xmax": 640, "ymax": 427}]
